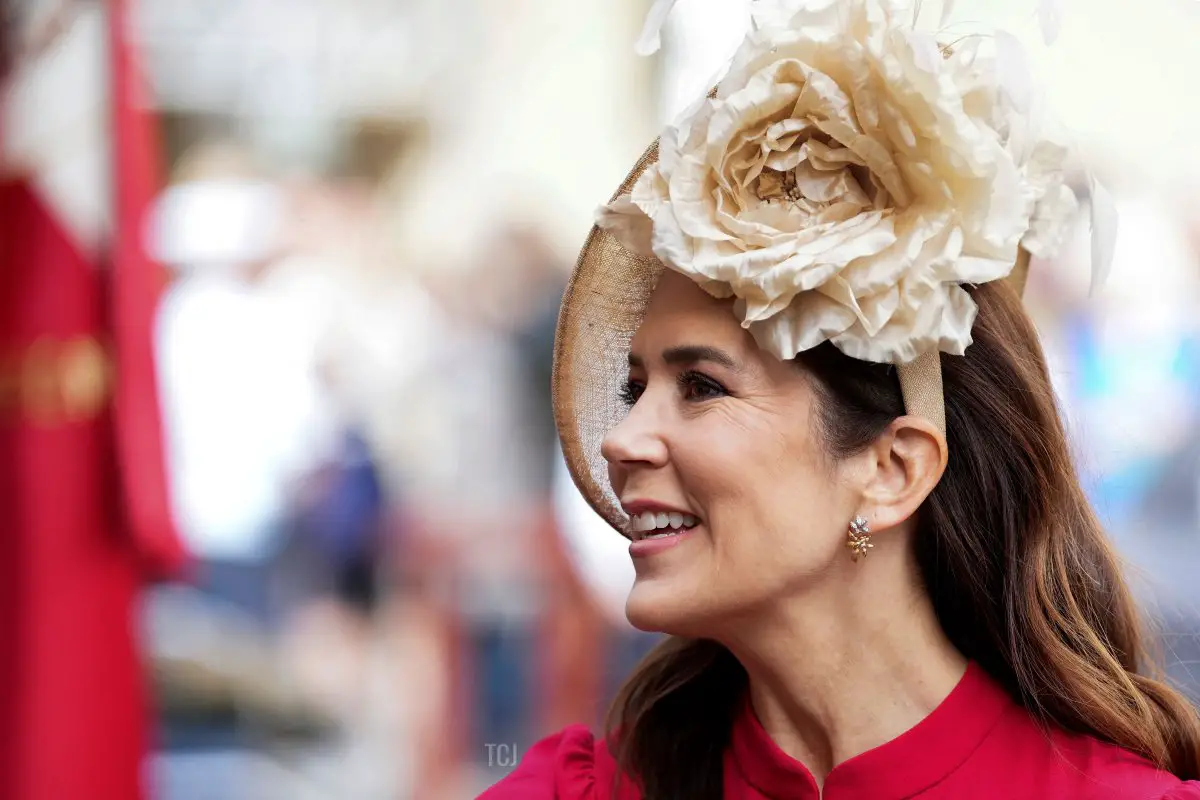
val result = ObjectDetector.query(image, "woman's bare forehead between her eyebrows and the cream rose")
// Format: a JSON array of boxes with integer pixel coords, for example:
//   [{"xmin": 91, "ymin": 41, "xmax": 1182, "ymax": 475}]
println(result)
[{"xmin": 631, "ymin": 270, "xmax": 758, "ymax": 356}]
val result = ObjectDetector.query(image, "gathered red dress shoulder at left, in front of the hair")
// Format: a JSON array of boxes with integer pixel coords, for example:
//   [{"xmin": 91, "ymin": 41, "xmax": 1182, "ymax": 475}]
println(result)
[{"xmin": 479, "ymin": 726, "xmax": 638, "ymax": 800}]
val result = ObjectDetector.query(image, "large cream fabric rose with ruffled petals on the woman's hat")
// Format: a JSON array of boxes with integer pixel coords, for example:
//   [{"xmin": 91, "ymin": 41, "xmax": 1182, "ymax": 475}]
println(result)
[{"xmin": 598, "ymin": 0, "xmax": 1076, "ymax": 363}]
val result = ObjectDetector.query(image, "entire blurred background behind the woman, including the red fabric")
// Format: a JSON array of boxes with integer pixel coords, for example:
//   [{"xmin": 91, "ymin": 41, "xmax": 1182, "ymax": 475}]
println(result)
[{"xmin": 0, "ymin": 0, "xmax": 1200, "ymax": 800}]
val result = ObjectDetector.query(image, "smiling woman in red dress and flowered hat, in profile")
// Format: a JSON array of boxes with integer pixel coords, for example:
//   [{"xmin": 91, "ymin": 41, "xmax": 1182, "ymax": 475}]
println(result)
[{"xmin": 484, "ymin": 0, "xmax": 1200, "ymax": 800}]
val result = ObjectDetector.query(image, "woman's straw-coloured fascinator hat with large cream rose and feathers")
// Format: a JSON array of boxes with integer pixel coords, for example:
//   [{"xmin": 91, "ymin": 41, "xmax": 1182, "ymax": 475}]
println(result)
[{"xmin": 552, "ymin": 0, "xmax": 1115, "ymax": 542}]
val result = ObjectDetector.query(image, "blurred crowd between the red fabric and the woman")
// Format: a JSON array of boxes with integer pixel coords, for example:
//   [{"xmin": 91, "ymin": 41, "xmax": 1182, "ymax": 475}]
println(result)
[{"xmin": 146, "ymin": 140, "xmax": 667, "ymax": 799}]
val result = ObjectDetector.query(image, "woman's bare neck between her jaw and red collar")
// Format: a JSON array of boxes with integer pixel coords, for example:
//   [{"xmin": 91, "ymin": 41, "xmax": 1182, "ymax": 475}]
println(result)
[{"xmin": 721, "ymin": 553, "xmax": 966, "ymax": 784}]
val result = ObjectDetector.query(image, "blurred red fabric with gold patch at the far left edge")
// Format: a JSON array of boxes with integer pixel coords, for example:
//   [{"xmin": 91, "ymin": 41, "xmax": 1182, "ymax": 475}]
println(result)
[{"xmin": 0, "ymin": 0, "xmax": 186, "ymax": 800}]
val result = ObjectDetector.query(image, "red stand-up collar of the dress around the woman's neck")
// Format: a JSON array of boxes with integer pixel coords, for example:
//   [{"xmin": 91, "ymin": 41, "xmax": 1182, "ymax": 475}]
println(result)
[{"xmin": 731, "ymin": 662, "xmax": 1012, "ymax": 800}]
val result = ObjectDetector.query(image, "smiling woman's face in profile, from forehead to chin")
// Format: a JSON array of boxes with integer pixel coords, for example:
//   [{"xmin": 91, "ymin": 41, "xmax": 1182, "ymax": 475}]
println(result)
[{"xmin": 602, "ymin": 270, "xmax": 860, "ymax": 636}]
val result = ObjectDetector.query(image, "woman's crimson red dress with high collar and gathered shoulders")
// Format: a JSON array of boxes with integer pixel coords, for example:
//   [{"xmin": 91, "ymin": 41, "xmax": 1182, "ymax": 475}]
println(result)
[{"xmin": 479, "ymin": 663, "xmax": 1200, "ymax": 800}]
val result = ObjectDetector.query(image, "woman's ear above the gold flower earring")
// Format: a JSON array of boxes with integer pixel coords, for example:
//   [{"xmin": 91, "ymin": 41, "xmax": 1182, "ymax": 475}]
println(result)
[{"xmin": 863, "ymin": 416, "xmax": 948, "ymax": 531}]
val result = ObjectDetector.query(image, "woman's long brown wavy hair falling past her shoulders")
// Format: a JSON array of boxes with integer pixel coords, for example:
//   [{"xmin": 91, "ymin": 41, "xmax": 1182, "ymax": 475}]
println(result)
[{"xmin": 607, "ymin": 282, "xmax": 1200, "ymax": 800}]
